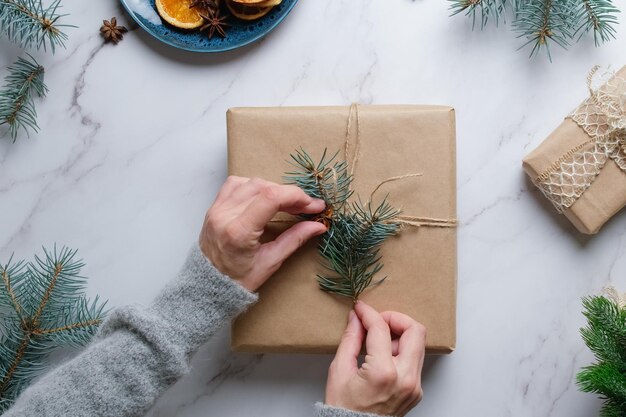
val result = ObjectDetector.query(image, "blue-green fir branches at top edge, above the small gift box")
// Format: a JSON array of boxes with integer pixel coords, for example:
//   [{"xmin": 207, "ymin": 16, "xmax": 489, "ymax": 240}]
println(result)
[{"xmin": 449, "ymin": 0, "xmax": 620, "ymax": 60}]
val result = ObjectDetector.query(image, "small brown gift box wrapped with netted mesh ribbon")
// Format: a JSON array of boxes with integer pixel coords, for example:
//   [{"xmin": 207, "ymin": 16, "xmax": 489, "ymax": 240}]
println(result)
[{"xmin": 523, "ymin": 67, "xmax": 626, "ymax": 234}]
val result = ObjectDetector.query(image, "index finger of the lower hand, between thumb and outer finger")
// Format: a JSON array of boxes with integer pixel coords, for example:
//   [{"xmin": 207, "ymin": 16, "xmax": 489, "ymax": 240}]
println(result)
[{"xmin": 354, "ymin": 301, "xmax": 392, "ymax": 361}]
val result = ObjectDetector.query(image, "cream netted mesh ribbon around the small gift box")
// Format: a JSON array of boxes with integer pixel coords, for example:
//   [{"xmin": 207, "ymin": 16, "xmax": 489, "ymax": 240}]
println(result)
[{"xmin": 533, "ymin": 66, "xmax": 626, "ymax": 213}]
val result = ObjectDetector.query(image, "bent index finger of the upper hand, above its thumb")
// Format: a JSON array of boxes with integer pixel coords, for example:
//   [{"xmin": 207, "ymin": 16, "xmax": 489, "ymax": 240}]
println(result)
[{"xmin": 241, "ymin": 185, "xmax": 324, "ymax": 230}]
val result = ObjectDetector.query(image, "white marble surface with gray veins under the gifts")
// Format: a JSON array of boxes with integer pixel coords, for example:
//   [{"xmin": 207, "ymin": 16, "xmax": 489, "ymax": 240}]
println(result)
[{"xmin": 0, "ymin": 0, "xmax": 626, "ymax": 417}]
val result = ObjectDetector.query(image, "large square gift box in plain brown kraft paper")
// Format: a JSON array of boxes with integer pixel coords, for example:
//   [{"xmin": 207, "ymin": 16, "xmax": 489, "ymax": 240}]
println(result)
[{"xmin": 227, "ymin": 105, "xmax": 456, "ymax": 353}]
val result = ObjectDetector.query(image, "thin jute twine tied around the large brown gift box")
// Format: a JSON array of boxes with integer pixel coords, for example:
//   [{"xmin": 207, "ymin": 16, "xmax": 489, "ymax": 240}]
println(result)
[{"xmin": 272, "ymin": 103, "xmax": 457, "ymax": 228}]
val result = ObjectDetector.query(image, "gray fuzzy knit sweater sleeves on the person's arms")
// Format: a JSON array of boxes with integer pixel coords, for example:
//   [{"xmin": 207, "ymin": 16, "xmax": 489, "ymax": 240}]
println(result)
[{"xmin": 3, "ymin": 246, "xmax": 382, "ymax": 417}]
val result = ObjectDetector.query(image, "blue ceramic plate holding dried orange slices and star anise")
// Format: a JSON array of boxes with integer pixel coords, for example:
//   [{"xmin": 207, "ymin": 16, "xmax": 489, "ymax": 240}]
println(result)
[{"xmin": 120, "ymin": 0, "xmax": 298, "ymax": 52}]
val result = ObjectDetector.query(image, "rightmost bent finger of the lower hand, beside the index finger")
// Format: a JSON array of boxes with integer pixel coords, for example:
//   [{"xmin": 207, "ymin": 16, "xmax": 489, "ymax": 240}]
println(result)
[{"xmin": 381, "ymin": 311, "xmax": 426, "ymax": 373}]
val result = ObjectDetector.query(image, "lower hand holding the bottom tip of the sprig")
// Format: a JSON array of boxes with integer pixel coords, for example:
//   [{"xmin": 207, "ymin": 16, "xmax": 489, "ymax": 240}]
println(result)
[{"xmin": 326, "ymin": 301, "xmax": 426, "ymax": 416}]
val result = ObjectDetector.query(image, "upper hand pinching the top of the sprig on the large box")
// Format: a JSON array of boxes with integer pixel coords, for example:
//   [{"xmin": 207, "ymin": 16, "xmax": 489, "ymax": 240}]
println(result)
[{"xmin": 200, "ymin": 176, "xmax": 326, "ymax": 291}]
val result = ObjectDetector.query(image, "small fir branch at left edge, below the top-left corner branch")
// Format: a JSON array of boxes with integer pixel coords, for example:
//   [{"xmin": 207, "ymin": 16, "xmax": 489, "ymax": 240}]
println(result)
[{"xmin": 0, "ymin": 54, "xmax": 48, "ymax": 142}]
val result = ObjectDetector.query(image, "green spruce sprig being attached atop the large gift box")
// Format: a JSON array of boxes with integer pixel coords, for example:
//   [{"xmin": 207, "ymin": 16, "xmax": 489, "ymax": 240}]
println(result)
[{"xmin": 285, "ymin": 149, "xmax": 400, "ymax": 302}]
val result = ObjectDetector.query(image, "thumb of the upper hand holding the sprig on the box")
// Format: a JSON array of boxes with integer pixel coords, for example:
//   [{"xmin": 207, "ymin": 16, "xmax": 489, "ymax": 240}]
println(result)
[{"xmin": 255, "ymin": 222, "xmax": 326, "ymax": 276}]
